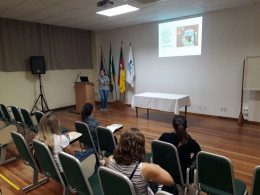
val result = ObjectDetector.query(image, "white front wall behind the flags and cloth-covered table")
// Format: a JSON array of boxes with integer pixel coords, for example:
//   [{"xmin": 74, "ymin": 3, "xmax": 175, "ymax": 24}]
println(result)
[{"xmin": 96, "ymin": 5, "xmax": 260, "ymax": 118}]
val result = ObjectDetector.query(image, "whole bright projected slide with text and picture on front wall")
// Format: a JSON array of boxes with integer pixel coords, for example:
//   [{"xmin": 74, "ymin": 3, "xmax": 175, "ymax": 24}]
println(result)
[{"xmin": 159, "ymin": 17, "xmax": 202, "ymax": 57}]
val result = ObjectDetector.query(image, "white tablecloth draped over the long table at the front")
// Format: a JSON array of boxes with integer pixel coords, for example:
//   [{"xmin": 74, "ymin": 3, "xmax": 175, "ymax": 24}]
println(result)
[{"xmin": 132, "ymin": 92, "xmax": 191, "ymax": 114}]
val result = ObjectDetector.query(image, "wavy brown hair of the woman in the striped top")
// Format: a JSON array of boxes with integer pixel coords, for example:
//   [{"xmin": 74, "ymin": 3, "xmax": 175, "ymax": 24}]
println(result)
[{"xmin": 114, "ymin": 128, "xmax": 145, "ymax": 165}]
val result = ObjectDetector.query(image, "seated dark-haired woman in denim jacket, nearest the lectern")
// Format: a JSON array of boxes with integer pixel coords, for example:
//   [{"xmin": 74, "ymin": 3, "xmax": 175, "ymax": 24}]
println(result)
[{"xmin": 81, "ymin": 103, "xmax": 117, "ymax": 151}]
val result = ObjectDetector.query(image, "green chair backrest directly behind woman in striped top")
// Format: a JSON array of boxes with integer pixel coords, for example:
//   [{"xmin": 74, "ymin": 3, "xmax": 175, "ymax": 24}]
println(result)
[{"xmin": 98, "ymin": 166, "xmax": 136, "ymax": 195}]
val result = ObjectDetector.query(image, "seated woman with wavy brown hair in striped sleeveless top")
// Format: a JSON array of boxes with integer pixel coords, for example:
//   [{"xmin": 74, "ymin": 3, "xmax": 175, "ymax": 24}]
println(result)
[{"xmin": 106, "ymin": 128, "xmax": 174, "ymax": 195}]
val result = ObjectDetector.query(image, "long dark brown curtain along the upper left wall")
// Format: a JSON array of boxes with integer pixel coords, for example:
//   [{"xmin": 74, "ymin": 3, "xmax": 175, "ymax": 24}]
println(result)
[{"xmin": 0, "ymin": 18, "xmax": 93, "ymax": 72}]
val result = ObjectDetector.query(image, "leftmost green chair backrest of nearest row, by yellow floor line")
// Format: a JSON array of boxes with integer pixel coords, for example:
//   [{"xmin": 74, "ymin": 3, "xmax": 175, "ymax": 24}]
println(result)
[{"xmin": 11, "ymin": 131, "xmax": 40, "ymax": 172}]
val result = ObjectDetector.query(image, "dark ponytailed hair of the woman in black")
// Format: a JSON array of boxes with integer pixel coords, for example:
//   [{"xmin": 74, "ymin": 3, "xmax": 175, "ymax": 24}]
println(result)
[{"xmin": 172, "ymin": 115, "xmax": 190, "ymax": 145}]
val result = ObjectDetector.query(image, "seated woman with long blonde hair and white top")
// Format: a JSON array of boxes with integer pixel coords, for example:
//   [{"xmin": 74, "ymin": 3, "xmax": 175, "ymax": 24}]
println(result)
[{"xmin": 35, "ymin": 112, "xmax": 97, "ymax": 173}]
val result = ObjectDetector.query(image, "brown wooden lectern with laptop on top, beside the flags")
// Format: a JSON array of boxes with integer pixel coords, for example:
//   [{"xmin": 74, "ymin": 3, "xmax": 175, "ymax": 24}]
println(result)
[{"xmin": 75, "ymin": 82, "xmax": 95, "ymax": 113}]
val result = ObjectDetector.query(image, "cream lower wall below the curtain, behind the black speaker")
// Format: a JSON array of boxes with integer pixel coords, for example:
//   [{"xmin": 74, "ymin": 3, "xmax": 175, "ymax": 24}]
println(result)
[{"xmin": 0, "ymin": 69, "xmax": 96, "ymax": 111}]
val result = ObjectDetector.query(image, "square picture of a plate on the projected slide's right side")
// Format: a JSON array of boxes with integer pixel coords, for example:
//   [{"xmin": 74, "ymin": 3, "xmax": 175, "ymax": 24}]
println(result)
[{"xmin": 176, "ymin": 24, "xmax": 199, "ymax": 47}]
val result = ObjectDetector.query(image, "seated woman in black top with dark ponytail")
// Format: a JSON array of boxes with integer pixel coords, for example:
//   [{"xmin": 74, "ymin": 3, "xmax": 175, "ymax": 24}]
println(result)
[{"xmin": 159, "ymin": 115, "xmax": 201, "ymax": 182}]
